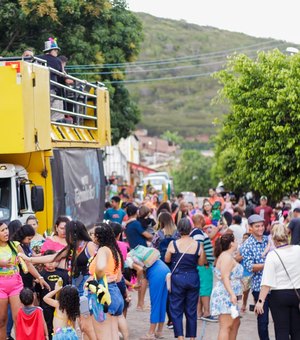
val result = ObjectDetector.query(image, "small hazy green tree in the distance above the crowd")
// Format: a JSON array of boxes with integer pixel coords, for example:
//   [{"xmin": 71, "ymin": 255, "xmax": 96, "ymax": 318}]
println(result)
[{"xmin": 172, "ymin": 150, "xmax": 213, "ymax": 196}]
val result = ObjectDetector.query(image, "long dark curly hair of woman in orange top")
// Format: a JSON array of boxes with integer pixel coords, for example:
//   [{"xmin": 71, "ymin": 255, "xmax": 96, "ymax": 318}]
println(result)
[{"xmin": 95, "ymin": 222, "xmax": 124, "ymax": 270}]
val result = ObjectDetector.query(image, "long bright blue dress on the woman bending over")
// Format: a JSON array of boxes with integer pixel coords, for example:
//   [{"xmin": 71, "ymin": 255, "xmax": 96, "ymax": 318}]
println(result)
[{"xmin": 146, "ymin": 260, "xmax": 170, "ymax": 323}]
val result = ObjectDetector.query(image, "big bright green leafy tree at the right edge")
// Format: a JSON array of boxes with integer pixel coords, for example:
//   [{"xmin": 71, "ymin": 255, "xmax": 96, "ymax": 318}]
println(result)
[{"xmin": 215, "ymin": 50, "xmax": 300, "ymax": 199}]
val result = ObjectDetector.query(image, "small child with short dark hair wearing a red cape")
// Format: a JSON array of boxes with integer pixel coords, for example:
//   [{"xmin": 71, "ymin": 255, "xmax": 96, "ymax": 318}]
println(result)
[{"xmin": 16, "ymin": 288, "xmax": 48, "ymax": 340}]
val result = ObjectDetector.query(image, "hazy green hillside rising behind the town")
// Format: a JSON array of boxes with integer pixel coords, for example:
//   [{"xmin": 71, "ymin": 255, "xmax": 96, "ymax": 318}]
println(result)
[{"xmin": 127, "ymin": 13, "xmax": 288, "ymax": 137}]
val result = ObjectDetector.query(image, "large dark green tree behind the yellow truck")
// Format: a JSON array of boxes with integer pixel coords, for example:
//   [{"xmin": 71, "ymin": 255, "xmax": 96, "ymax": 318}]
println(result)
[{"xmin": 0, "ymin": 0, "xmax": 143, "ymax": 143}]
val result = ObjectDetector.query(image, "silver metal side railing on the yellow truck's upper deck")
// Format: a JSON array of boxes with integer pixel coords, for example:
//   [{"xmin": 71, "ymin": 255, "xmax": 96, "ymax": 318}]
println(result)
[{"xmin": 33, "ymin": 57, "xmax": 110, "ymax": 144}]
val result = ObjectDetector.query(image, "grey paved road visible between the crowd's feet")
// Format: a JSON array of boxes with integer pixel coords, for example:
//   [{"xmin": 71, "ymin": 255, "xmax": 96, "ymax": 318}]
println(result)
[{"xmin": 127, "ymin": 292, "xmax": 275, "ymax": 340}]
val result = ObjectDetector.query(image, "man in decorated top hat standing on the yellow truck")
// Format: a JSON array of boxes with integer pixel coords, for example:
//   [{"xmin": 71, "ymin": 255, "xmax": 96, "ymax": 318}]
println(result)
[{"xmin": 38, "ymin": 38, "xmax": 66, "ymax": 123}]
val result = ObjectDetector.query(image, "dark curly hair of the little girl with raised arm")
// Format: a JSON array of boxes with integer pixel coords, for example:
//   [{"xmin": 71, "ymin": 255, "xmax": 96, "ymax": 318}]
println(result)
[{"xmin": 58, "ymin": 285, "xmax": 80, "ymax": 322}]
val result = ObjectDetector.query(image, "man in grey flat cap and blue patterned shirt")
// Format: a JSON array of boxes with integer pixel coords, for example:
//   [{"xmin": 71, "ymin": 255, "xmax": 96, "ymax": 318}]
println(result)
[{"xmin": 240, "ymin": 214, "xmax": 269, "ymax": 340}]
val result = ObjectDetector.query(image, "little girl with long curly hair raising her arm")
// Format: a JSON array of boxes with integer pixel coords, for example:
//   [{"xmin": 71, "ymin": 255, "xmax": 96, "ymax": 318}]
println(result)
[{"xmin": 43, "ymin": 283, "xmax": 80, "ymax": 340}]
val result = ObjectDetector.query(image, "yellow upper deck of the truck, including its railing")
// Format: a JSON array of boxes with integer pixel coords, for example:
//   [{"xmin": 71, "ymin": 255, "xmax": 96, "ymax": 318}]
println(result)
[{"xmin": 0, "ymin": 57, "xmax": 111, "ymax": 149}]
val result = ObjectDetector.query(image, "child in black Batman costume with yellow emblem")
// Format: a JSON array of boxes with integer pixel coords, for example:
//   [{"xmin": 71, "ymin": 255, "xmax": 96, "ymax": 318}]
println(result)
[{"xmin": 35, "ymin": 250, "xmax": 69, "ymax": 340}]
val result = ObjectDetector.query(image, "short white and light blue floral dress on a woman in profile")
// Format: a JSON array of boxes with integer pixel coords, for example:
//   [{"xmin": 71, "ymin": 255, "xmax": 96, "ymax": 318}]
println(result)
[{"xmin": 210, "ymin": 263, "xmax": 244, "ymax": 316}]
